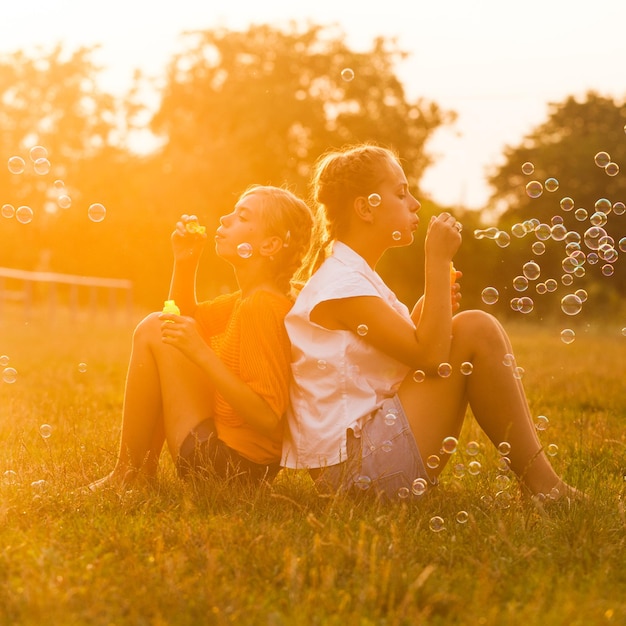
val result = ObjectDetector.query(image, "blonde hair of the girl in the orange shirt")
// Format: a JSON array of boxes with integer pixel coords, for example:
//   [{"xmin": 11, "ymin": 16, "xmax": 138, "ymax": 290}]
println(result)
[{"xmin": 239, "ymin": 185, "xmax": 313, "ymax": 296}]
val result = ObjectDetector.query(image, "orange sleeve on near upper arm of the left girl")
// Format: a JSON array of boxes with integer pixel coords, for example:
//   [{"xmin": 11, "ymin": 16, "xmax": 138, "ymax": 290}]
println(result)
[{"xmin": 240, "ymin": 292, "xmax": 291, "ymax": 416}]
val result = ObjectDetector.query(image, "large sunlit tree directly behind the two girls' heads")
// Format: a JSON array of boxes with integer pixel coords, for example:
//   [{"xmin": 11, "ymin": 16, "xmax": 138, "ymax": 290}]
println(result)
[{"xmin": 146, "ymin": 24, "xmax": 452, "ymax": 296}]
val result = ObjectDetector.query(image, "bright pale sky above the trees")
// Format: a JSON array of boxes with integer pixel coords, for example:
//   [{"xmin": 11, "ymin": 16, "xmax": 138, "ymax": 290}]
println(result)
[{"xmin": 0, "ymin": 0, "xmax": 626, "ymax": 208}]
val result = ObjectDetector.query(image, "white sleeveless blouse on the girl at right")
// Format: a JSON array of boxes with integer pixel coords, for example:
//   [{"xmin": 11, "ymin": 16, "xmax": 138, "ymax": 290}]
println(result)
[{"xmin": 282, "ymin": 241, "xmax": 413, "ymax": 468}]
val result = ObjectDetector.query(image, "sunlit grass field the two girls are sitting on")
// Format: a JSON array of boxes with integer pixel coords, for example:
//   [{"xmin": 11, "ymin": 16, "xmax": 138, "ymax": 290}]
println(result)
[{"xmin": 0, "ymin": 308, "xmax": 626, "ymax": 626}]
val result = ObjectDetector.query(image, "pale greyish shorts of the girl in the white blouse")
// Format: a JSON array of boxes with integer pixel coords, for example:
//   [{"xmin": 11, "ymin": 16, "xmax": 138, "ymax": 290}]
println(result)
[{"xmin": 315, "ymin": 396, "xmax": 437, "ymax": 501}]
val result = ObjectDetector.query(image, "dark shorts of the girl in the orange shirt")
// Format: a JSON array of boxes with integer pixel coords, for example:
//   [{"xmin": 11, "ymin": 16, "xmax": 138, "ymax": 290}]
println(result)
[{"xmin": 176, "ymin": 419, "xmax": 280, "ymax": 485}]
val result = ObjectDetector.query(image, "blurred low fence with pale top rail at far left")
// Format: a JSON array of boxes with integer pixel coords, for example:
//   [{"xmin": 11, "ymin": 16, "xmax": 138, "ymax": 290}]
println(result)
[{"xmin": 0, "ymin": 267, "xmax": 133, "ymax": 319}]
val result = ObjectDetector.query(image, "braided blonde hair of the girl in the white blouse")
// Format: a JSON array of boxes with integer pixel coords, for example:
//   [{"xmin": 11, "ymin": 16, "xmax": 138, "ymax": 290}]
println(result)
[{"xmin": 296, "ymin": 143, "xmax": 400, "ymax": 285}]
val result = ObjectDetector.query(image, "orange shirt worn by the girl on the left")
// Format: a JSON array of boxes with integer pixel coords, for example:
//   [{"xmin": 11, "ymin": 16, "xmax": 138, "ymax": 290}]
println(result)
[{"xmin": 195, "ymin": 291, "xmax": 293, "ymax": 464}]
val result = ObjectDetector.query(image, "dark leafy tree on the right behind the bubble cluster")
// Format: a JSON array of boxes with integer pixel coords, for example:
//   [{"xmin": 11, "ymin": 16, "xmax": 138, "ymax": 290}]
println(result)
[{"xmin": 478, "ymin": 92, "xmax": 626, "ymax": 312}]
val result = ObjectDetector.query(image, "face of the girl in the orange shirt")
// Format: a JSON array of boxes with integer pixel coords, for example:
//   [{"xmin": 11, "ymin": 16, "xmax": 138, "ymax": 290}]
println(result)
[{"xmin": 215, "ymin": 192, "xmax": 266, "ymax": 262}]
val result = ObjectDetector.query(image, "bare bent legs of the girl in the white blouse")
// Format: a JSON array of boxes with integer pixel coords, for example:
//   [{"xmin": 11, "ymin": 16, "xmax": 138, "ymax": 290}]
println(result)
[{"xmin": 399, "ymin": 311, "xmax": 575, "ymax": 495}]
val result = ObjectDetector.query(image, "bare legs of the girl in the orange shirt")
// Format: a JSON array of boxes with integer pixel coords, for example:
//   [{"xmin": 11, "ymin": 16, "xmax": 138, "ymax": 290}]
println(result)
[{"xmin": 90, "ymin": 314, "xmax": 211, "ymax": 488}]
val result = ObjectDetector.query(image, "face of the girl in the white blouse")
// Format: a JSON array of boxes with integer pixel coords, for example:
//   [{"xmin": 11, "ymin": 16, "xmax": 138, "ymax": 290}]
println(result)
[{"xmin": 368, "ymin": 159, "xmax": 420, "ymax": 247}]
